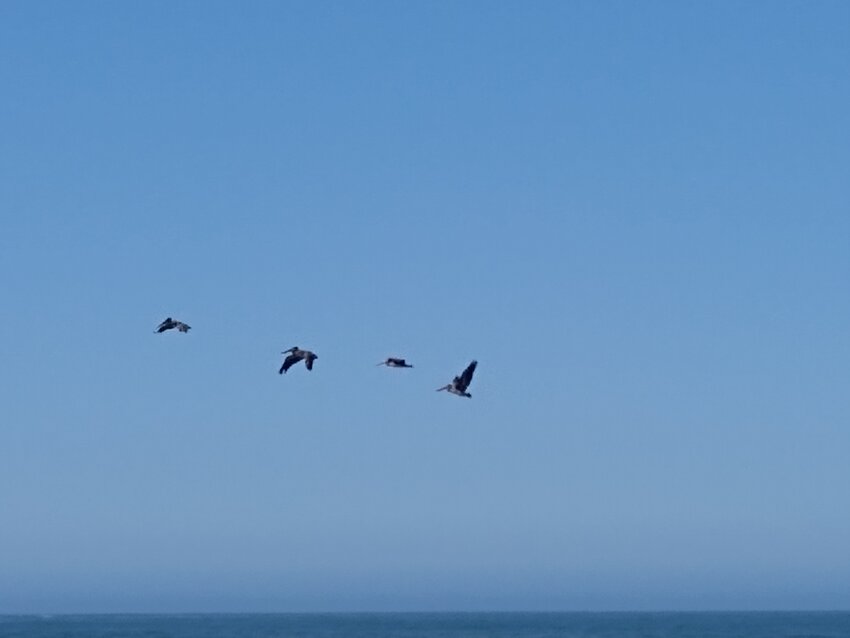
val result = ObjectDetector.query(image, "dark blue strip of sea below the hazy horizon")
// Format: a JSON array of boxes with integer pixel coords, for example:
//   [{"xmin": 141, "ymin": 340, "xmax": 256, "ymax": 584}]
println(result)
[{"xmin": 0, "ymin": 612, "xmax": 850, "ymax": 638}]
